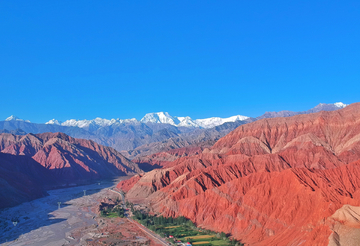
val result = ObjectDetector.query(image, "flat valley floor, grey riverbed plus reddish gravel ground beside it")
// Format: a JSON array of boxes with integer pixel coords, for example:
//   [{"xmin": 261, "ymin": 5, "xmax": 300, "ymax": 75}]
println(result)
[{"xmin": 0, "ymin": 180, "xmax": 160, "ymax": 246}]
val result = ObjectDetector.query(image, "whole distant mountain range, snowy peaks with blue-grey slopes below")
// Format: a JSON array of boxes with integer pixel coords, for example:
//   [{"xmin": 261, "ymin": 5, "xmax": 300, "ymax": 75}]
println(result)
[{"xmin": 0, "ymin": 103, "xmax": 347, "ymax": 158}]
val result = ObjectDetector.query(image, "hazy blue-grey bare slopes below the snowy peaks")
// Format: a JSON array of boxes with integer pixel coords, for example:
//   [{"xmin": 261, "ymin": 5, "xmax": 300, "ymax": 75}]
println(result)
[{"xmin": 0, "ymin": 116, "xmax": 253, "ymax": 155}]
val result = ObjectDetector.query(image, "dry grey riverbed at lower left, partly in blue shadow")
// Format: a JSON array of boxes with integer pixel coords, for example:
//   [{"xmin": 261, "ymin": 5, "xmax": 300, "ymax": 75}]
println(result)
[{"xmin": 0, "ymin": 179, "xmax": 143, "ymax": 246}]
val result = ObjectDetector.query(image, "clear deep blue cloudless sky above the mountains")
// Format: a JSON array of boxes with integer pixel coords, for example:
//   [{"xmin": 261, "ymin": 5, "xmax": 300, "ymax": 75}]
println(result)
[{"xmin": 0, "ymin": 0, "xmax": 360, "ymax": 123}]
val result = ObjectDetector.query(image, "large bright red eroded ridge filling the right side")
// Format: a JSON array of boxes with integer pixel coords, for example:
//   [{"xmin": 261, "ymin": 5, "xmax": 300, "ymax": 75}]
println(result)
[{"xmin": 119, "ymin": 103, "xmax": 360, "ymax": 245}]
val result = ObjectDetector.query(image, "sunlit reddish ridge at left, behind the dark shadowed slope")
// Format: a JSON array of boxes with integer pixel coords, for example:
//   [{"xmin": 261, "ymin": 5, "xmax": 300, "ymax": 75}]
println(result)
[{"xmin": 0, "ymin": 133, "xmax": 142, "ymax": 184}]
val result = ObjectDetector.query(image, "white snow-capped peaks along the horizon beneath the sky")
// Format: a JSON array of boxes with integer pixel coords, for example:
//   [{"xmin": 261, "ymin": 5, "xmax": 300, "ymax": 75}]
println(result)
[{"xmin": 5, "ymin": 102, "xmax": 347, "ymax": 129}]
